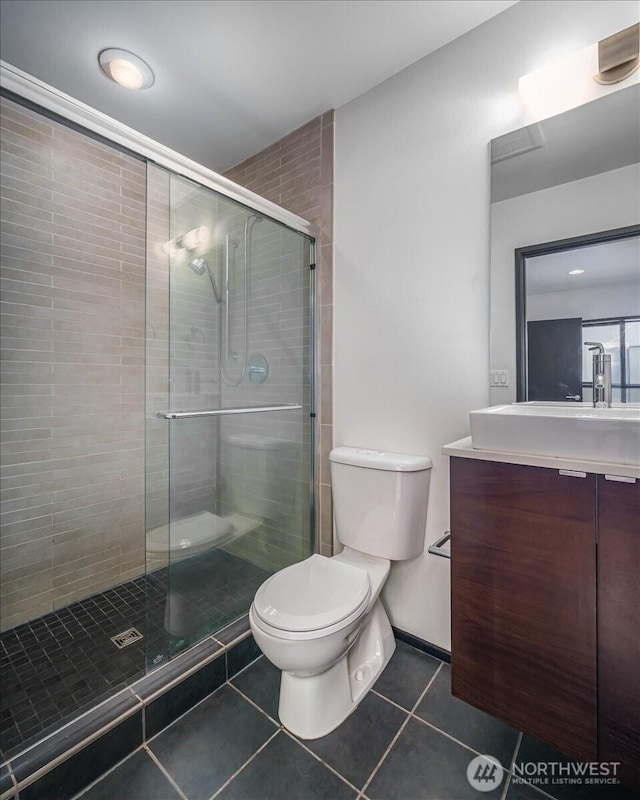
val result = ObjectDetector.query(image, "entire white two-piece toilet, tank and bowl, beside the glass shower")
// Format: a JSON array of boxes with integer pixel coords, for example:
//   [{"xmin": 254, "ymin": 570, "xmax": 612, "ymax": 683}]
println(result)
[{"xmin": 249, "ymin": 447, "xmax": 431, "ymax": 739}]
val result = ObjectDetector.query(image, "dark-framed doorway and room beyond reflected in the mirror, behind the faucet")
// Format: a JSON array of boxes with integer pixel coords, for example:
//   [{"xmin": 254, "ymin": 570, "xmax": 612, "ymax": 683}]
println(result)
[{"xmin": 516, "ymin": 226, "xmax": 640, "ymax": 403}]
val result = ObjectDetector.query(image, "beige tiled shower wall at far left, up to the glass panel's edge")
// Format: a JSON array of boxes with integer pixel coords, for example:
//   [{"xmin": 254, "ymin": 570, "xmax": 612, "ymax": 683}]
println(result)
[{"xmin": 0, "ymin": 99, "xmax": 145, "ymax": 629}]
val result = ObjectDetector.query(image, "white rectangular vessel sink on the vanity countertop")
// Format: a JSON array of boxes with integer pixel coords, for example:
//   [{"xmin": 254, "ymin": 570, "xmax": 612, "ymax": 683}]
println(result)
[{"xmin": 469, "ymin": 403, "xmax": 640, "ymax": 466}]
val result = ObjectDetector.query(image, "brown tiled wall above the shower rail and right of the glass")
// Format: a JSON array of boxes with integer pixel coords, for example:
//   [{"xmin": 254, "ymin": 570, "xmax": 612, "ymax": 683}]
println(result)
[{"xmin": 225, "ymin": 111, "xmax": 334, "ymax": 555}]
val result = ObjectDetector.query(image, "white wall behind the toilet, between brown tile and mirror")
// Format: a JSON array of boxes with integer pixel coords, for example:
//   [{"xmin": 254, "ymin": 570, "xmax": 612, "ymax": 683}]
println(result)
[{"xmin": 334, "ymin": 0, "xmax": 637, "ymax": 648}]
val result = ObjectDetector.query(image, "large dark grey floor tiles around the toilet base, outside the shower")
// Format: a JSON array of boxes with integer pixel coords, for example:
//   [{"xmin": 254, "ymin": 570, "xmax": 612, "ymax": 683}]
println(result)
[{"xmin": 71, "ymin": 643, "xmax": 634, "ymax": 800}]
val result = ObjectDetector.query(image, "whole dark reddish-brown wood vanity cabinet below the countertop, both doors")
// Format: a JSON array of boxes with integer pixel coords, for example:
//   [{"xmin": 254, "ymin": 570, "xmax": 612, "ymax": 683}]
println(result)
[{"xmin": 451, "ymin": 457, "xmax": 640, "ymax": 785}]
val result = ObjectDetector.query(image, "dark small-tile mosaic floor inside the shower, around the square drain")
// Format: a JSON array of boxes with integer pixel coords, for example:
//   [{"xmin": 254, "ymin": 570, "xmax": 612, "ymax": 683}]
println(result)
[{"xmin": 0, "ymin": 550, "xmax": 269, "ymax": 761}]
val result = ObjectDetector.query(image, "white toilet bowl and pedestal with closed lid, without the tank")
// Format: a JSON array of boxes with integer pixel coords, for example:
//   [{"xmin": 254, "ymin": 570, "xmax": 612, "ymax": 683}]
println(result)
[{"xmin": 249, "ymin": 549, "xmax": 395, "ymax": 739}]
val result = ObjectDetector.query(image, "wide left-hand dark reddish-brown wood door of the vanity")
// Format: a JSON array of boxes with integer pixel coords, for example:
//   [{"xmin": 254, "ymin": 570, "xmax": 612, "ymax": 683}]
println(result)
[{"xmin": 451, "ymin": 458, "xmax": 597, "ymax": 761}]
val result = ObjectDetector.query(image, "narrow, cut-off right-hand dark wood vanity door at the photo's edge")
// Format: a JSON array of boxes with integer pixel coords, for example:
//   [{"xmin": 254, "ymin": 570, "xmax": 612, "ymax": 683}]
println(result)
[{"xmin": 598, "ymin": 475, "xmax": 640, "ymax": 788}]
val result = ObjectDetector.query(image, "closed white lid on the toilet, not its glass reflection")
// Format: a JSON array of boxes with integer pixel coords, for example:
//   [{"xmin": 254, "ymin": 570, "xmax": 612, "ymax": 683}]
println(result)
[{"xmin": 253, "ymin": 555, "xmax": 371, "ymax": 631}]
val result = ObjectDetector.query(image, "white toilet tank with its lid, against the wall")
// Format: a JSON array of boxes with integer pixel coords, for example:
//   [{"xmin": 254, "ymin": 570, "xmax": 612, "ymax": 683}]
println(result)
[{"xmin": 329, "ymin": 447, "xmax": 431, "ymax": 561}]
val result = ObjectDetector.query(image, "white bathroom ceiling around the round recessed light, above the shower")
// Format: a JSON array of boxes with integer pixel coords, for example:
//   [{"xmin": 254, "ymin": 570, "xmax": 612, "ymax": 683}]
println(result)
[{"xmin": 0, "ymin": 0, "xmax": 517, "ymax": 172}]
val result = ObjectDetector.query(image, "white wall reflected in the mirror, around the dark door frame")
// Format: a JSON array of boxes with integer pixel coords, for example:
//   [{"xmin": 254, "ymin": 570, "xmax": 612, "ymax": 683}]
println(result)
[{"xmin": 491, "ymin": 164, "xmax": 640, "ymax": 405}]
